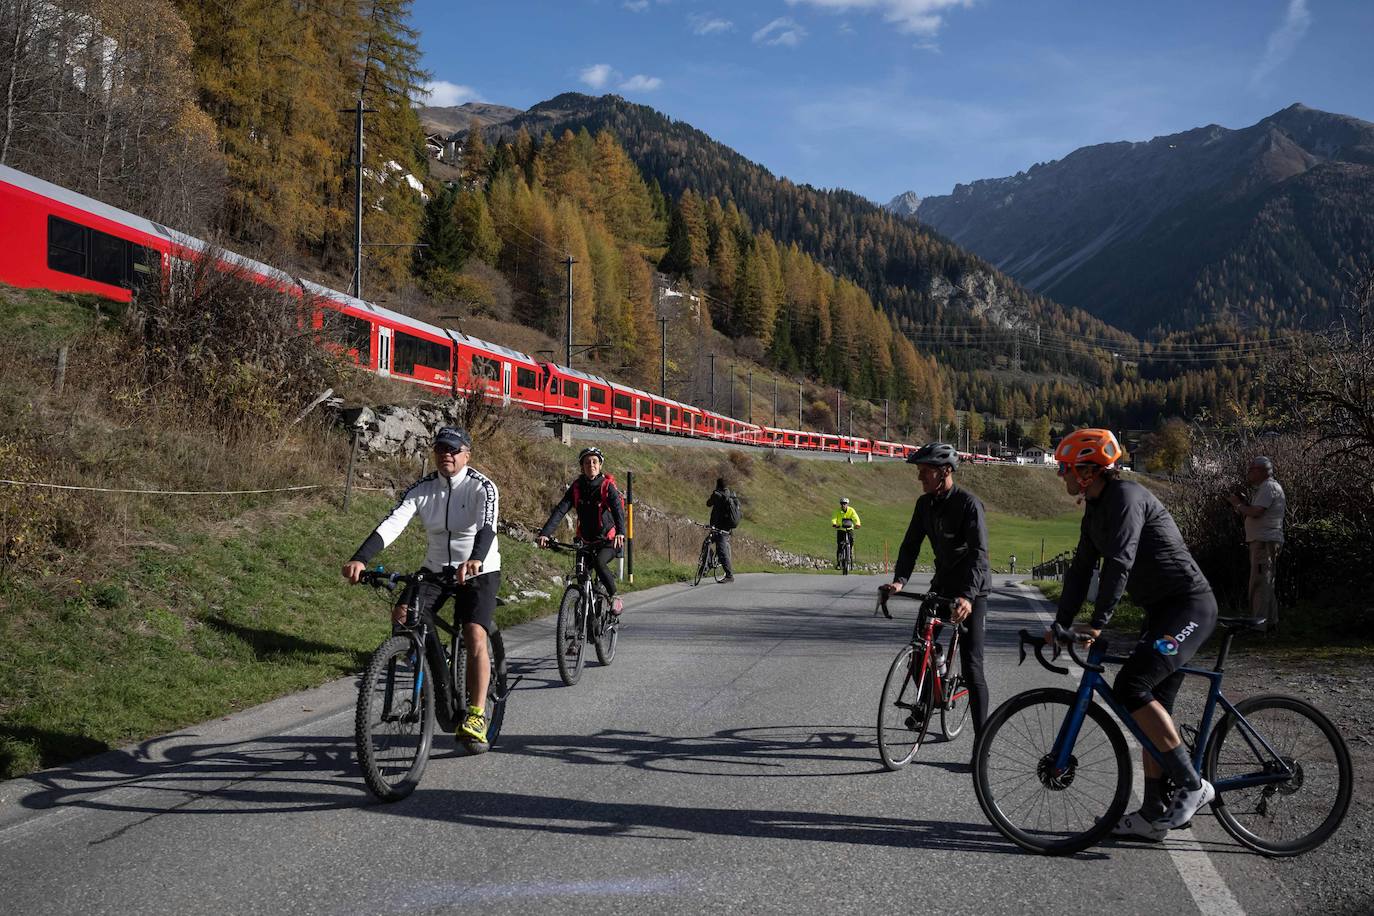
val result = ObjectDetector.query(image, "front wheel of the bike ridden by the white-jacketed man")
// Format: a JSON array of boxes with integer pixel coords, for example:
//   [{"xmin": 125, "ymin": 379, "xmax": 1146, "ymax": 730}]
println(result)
[{"xmin": 353, "ymin": 636, "xmax": 434, "ymax": 802}]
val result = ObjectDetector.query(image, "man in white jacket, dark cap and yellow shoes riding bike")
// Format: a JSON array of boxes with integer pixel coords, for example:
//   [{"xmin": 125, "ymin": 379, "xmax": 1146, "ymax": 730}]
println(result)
[{"xmin": 344, "ymin": 426, "xmax": 502, "ymax": 748}]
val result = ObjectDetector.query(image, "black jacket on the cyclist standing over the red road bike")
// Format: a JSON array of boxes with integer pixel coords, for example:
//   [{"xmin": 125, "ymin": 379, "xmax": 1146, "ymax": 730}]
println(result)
[{"xmin": 892, "ymin": 486, "xmax": 992, "ymax": 602}]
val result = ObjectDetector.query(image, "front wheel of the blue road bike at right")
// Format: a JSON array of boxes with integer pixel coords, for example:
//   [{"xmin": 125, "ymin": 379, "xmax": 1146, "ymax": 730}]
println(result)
[{"xmin": 973, "ymin": 687, "xmax": 1131, "ymax": 856}]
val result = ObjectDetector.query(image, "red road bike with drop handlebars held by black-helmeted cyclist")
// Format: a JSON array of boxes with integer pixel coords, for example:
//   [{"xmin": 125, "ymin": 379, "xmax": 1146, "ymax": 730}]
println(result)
[{"xmin": 875, "ymin": 589, "xmax": 969, "ymax": 770}]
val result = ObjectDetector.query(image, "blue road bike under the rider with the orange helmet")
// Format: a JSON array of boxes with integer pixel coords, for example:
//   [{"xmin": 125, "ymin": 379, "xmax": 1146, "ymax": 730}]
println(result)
[{"xmin": 973, "ymin": 617, "xmax": 1353, "ymax": 856}]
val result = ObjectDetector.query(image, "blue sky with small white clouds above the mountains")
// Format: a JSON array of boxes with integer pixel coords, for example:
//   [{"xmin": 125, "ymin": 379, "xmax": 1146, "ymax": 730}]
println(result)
[{"xmin": 412, "ymin": 0, "xmax": 1374, "ymax": 202}]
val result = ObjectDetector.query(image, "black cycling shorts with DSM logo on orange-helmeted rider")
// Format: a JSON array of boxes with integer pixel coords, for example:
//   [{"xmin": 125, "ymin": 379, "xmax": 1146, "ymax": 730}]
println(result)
[{"xmin": 1112, "ymin": 591, "xmax": 1216, "ymax": 713}]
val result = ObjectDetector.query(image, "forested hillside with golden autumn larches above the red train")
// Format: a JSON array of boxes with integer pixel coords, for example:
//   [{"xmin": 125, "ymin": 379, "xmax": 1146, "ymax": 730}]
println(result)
[{"xmin": 0, "ymin": 0, "xmax": 1285, "ymax": 438}]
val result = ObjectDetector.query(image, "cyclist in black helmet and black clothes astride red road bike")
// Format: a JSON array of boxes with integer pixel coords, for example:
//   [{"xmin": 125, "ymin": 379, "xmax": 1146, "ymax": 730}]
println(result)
[{"xmin": 885, "ymin": 442, "xmax": 992, "ymax": 735}]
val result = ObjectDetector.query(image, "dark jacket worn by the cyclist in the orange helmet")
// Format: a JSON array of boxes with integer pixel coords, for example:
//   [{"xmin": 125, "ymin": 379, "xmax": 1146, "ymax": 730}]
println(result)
[{"xmin": 1055, "ymin": 478, "xmax": 1212, "ymax": 629}]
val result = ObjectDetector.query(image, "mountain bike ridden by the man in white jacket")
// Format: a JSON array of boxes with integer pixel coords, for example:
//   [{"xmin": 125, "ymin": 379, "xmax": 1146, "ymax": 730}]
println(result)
[{"xmin": 354, "ymin": 569, "xmax": 521, "ymax": 802}]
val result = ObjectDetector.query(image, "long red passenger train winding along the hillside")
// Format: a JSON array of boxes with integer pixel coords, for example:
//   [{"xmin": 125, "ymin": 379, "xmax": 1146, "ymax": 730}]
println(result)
[{"xmin": 0, "ymin": 166, "xmax": 956, "ymax": 457}]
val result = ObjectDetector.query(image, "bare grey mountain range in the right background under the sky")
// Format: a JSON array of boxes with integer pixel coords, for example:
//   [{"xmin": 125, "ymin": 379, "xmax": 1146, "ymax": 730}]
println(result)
[{"xmin": 906, "ymin": 104, "xmax": 1374, "ymax": 334}]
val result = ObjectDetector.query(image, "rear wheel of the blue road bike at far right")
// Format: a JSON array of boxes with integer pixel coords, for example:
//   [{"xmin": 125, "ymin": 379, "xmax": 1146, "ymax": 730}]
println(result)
[{"xmin": 1202, "ymin": 695, "xmax": 1355, "ymax": 856}]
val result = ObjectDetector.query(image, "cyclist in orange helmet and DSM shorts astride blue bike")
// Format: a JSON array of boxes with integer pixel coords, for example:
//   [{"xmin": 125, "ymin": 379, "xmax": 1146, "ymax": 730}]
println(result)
[{"xmin": 1046, "ymin": 428, "xmax": 1216, "ymax": 840}]
